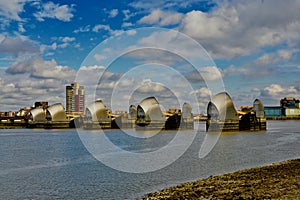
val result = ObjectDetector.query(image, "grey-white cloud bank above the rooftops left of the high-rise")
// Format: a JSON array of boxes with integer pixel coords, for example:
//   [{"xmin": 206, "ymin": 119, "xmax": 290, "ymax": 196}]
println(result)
[{"xmin": 0, "ymin": 57, "xmax": 75, "ymax": 111}]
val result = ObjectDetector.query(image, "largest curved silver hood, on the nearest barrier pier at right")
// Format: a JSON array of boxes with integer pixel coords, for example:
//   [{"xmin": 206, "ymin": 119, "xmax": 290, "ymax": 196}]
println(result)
[{"xmin": 207, "ymin": 92, "xmax": 239, "ymax": 121}]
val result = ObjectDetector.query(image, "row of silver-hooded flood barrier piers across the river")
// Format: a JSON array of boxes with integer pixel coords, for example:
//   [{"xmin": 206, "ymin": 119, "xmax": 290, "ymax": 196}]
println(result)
[{"xmin": 0, "ymin": 92, "xmax": 267, "ymax": 132}]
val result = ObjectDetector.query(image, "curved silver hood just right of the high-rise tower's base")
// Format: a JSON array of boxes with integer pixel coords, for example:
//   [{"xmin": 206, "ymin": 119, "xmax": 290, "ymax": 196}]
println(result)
[{"xmin": 85, "ymin": 101, "xmax": 109, "ymax": 122}]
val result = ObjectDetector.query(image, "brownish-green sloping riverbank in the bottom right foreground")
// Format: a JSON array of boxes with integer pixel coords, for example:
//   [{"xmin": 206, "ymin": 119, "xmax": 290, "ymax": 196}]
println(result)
[{"xmin": 142, "ymin": 159, "xmax": 300, "ymax": 200}]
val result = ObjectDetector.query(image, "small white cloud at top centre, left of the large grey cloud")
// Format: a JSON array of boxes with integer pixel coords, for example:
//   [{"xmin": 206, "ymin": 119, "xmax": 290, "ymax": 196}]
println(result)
[{"xmin": 138, "ymin": 9, "xmax": 183, "ymax": 26}]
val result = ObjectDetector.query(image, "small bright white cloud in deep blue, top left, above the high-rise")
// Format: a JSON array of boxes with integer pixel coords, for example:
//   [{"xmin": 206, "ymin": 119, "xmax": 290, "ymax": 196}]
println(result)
[{"xmin": 34, "ymin": 1, "xmax": 74, "ymax": 22}]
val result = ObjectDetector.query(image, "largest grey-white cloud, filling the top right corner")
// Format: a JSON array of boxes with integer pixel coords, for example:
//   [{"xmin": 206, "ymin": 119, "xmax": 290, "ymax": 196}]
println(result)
[{"xmin": 180, "ymin": 0, "xmax": 300, "ymax": 58}]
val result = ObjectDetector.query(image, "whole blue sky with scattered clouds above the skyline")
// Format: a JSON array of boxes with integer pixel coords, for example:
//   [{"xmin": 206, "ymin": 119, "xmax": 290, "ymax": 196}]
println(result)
[{"xmin": 0, "ymin": 0, "xmax": 300, "ymax": 112}]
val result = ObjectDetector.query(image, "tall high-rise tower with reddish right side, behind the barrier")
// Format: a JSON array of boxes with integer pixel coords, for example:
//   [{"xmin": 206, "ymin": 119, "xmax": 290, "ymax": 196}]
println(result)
[{"xmin": 66, "ymin": 82, "xmax": 85, "ymax": 114}]
